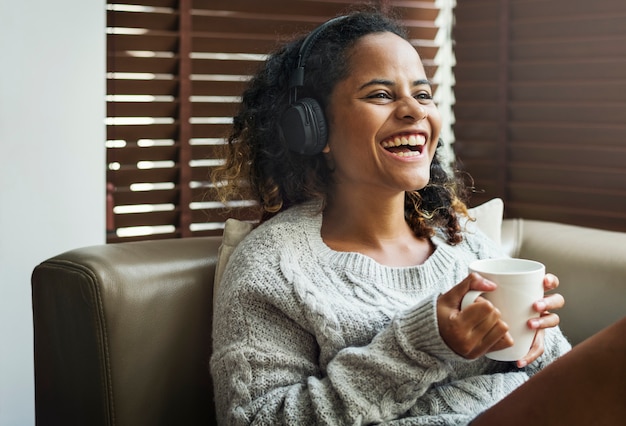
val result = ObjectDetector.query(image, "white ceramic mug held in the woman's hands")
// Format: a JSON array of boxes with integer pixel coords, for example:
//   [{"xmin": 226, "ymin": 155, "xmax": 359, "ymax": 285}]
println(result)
[{"xmin": 461, "ymin": 258, "xmax": 546, "ymax": 361}]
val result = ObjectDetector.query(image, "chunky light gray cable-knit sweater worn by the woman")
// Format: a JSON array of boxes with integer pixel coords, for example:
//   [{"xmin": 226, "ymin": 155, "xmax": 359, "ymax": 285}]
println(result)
[{"xmin": 211, "ymin": 204, "xmax": 570, "ymax": 425}]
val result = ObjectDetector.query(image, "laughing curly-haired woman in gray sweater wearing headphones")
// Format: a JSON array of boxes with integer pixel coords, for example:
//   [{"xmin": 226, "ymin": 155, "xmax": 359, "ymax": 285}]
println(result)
[{"xmin": 211, "ymin": 13, "xmax": 623, "ymax": 425}]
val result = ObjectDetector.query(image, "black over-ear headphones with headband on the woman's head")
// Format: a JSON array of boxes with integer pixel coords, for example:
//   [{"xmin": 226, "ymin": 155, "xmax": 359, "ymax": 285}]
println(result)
[{"xmin": 280, "ymin": 16, "xmax": 345, "ymax": 155}]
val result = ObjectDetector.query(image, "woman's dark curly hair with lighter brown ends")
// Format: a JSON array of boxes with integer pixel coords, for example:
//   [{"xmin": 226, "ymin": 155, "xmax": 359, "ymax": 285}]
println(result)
[{"xmin": 212, "ymin": 11, "xmax": 467, "ymax": 244}]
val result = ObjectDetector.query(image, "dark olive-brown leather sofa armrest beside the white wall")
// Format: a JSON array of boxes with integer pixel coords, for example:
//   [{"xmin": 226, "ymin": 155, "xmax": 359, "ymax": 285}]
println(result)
[{"xmin": 32, "ymin": 237, "xmax": 221, "ymax": 426}]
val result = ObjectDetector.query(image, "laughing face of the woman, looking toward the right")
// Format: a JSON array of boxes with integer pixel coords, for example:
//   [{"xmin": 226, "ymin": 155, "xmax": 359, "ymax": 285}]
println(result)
[{"xmin": 324, "ymin": 33, "xmax": 441, "ymax": 194}]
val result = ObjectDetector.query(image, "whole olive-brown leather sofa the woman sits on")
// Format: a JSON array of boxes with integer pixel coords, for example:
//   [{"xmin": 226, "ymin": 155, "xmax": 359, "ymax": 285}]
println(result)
[{"xmin": 32, "ymin": 219, "xmax": 626, "ymax": 426}]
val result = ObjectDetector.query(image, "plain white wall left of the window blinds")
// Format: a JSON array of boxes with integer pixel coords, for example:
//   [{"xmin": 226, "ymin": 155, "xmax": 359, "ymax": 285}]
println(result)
[{"xmin": 0, "ymin": 0, "xmax": 106, "ymax": 426}]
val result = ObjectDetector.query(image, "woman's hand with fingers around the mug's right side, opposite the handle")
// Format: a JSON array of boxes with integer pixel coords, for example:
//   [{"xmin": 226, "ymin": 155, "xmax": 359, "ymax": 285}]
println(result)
[{"xmin": 517, "ymin": 274, "xmax": 565, "ymax": 368}]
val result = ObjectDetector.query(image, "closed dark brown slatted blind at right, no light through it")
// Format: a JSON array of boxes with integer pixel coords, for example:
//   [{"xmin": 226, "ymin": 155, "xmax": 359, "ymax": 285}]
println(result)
[{"xmin": 453, "ymin": 0, "xmax": 626, "ymax": 231}]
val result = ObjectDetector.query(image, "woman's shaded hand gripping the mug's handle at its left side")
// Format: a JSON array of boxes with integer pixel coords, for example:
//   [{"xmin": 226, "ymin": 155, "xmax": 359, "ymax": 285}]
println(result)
[{"xmin": 437, "ymin": 273, "xmax": 512, "ymax": 359}]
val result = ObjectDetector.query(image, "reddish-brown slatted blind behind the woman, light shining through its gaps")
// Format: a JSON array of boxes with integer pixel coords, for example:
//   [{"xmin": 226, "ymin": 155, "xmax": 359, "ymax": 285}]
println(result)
[{"xmin": 106, "ymin": 0, "xmax": 453, "ymax": 242}]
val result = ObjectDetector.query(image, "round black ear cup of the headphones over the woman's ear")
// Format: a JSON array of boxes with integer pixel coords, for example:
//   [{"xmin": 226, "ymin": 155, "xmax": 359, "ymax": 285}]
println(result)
[{"xmin": 280, "ymin": 98, "xmax": 328, "ymax": 155}]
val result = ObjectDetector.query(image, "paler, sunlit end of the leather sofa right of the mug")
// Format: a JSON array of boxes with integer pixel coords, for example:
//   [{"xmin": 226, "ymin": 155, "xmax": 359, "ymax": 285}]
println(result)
[{"xmin": 502, "ymin": 219, "xmax": 626, "ymax": 344}]
